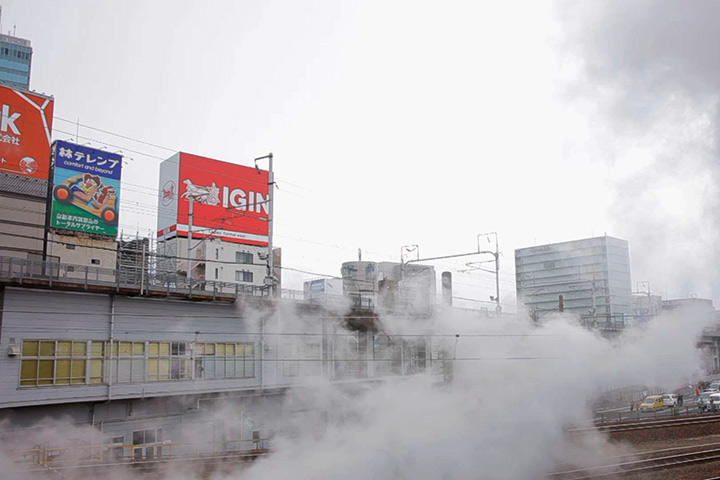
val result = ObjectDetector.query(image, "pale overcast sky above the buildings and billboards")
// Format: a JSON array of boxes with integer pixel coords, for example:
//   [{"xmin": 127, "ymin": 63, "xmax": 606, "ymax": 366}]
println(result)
[{"xmin": 9, "ymin": 0, "xmax": 720, "ymax": 310}]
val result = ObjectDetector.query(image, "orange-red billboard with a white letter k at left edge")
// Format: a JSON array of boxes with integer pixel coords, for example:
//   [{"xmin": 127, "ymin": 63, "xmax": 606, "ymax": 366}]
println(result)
[{"xmin": 0, "ymin": 86, "xmax": 54, "ymax": 180}]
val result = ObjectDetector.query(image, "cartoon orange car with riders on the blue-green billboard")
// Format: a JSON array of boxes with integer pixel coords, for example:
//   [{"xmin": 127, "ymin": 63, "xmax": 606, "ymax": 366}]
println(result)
[{"xmin": 53, "ymin": 173, "xmax": 118, "ymax": 225}]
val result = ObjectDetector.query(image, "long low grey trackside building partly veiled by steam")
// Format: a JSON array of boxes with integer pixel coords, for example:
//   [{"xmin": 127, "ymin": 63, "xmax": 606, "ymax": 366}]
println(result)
[{"xmin": 0, "ymin": 263, "xmax": 444, "ymax": 478}]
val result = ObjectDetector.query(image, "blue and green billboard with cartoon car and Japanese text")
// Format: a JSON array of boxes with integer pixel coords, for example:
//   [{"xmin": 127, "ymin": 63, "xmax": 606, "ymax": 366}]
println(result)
[{"xmin": 50, "ymin": 140, "xmax": 122, "ymax": 237}]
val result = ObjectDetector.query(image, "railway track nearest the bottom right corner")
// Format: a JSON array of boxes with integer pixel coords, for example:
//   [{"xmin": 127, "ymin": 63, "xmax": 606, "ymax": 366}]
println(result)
[{"xmin": 546, "ymin": 443, "xmax": 720, "ymax": 480}]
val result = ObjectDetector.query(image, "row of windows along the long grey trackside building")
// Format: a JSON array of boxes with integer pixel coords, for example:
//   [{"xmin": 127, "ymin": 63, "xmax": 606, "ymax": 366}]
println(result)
[{"xmin": 19, "ymin": 335, "xmax": 442, "ymax": 388}]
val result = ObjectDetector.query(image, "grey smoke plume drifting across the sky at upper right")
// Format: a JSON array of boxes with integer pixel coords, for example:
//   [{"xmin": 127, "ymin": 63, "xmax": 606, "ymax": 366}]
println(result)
[{"xmin": 556, "ymin": 0, "xmax": 720, "ymax": 299}]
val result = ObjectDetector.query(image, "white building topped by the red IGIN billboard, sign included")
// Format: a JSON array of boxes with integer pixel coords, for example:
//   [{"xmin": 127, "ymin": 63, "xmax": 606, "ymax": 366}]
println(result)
[{"xmin": 157, "ymin": 152, "xmax": 280, "ymax": 289}]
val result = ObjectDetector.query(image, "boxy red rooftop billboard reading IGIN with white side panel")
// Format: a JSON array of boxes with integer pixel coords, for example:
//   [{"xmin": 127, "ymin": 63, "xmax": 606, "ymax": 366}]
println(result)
[{"xmin": 158, "ymin": 153, "xmax": 270, "ymax": 246}]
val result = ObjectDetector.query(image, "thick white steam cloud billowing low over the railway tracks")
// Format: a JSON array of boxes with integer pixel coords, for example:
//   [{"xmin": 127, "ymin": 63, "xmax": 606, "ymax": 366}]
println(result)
[{"xmin": 228, "ymin": 314, "xmax": 704, "ymax": 480}]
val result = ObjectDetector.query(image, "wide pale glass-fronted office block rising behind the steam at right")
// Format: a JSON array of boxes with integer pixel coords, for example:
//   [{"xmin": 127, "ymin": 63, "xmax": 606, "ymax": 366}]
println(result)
[{"xmin": 515, "ymin": 236, "xmax": 632, "ymax": 322}]
